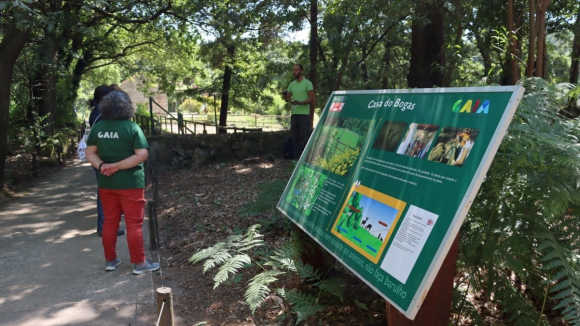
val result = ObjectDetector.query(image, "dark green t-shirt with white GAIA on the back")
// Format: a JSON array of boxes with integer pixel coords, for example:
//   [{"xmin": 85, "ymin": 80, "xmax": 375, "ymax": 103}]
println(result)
[{"xmin": 87, "ymin": 120, "xmax": 149, "ymax": 189}]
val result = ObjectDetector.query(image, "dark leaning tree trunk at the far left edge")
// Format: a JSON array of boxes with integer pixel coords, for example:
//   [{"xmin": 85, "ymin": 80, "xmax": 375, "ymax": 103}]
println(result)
[{"xmin": 0, "ymin": 21, "xmax": 30, "ymax": 187}]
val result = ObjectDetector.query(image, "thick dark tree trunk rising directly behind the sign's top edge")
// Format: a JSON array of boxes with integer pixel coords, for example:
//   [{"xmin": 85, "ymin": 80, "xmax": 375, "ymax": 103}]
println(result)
[{"xmin": 407, "ymin": 0, "xmax": 445, "ymax": 88}]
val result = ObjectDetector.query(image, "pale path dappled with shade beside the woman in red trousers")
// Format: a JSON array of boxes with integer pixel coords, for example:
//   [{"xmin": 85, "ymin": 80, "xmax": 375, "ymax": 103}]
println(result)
[{"xmin": 0, "ymin": 161, "xmax": 159, "ymax": 326}]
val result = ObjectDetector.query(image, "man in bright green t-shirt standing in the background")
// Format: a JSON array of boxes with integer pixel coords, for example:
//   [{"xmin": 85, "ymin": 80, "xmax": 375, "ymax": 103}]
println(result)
[{"xmin": 282, "ymin": 64, "xmax": 315, "ymax": 158}]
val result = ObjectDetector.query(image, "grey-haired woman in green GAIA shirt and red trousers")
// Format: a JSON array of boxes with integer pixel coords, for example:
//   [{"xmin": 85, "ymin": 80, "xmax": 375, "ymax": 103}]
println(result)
[{"xmin": 86, "ymin": 91, "xmax": 159, "ymax": 275}]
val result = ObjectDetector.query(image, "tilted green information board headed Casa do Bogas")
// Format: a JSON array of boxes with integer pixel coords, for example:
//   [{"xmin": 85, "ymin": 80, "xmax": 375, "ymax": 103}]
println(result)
[{"xmin": 277, "ymin": 86, "xmax": 524, "ymax": 319}]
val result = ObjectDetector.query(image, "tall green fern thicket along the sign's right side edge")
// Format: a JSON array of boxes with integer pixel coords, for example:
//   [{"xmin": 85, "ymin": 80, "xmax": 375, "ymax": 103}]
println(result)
[{"xmin": 456, "ymin": 78, "xmax": 580, "ymax": 325}]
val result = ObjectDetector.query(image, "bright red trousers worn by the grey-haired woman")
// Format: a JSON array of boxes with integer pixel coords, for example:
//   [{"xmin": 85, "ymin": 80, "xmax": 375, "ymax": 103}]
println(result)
[{"xmin": 99, "ymin": 188, "xmax": 145, "ymax": 264}]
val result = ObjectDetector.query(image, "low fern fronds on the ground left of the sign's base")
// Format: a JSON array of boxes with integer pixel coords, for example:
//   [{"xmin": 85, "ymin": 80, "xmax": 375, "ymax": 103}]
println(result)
[{"xmin": 190, "ymin": 225, "xmax": 343, "ymax": 324}]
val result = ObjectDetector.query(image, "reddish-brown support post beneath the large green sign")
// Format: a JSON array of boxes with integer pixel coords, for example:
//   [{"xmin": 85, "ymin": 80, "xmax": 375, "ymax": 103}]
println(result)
[{"xmin": 387, "ymin": 234, "xmax": 459, "ymax": 326}]
